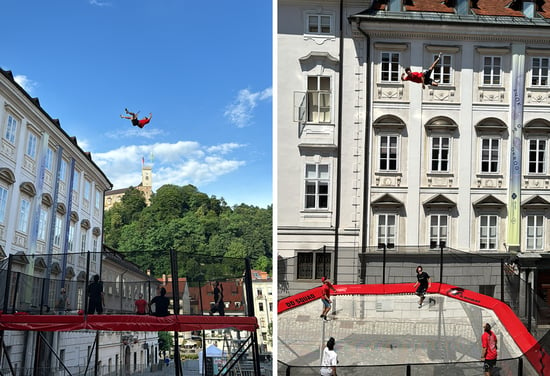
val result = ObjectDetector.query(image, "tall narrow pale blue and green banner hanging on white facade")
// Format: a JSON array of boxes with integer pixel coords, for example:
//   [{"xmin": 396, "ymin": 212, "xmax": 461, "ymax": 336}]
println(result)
[{"xmin": 507, "ymin": 45, "xmax": 525, "ymax": 251}]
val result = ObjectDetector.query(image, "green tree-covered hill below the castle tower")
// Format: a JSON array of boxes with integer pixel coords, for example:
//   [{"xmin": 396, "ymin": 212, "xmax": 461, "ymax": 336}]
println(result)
[{"xmin": 103, "ymin": 185, "xmax": 273, "ymax": 276}]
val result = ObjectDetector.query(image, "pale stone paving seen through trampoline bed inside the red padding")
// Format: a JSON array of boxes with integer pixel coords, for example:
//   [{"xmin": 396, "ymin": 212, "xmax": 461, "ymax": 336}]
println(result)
[{"xmin": 277, "ymin": 294, "xmax": 521, "ymax": 367}]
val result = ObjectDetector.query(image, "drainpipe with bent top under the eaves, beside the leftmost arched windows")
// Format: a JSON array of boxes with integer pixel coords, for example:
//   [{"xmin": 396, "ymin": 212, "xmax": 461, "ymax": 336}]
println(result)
[{"xmin": 355, "ymin": 18, "xmax": 371, "ymax": 284}]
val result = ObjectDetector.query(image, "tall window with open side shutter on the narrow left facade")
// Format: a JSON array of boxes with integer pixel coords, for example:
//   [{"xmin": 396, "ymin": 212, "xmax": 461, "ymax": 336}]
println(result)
[{"xmin": 307, "ymin": 76, "xmax": 332, "ymax": 123}]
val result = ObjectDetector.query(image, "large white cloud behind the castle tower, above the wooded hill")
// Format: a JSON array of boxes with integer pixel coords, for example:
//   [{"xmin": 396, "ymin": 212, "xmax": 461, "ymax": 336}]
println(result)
[{"xmin": 93, "ymin": 141, "xmax": 246, "ymax": 190}]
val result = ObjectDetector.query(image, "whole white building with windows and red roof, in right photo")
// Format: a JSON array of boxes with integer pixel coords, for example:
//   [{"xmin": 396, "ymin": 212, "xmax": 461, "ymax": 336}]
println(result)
[{"xmin": 276, "ymin": 0, "xmax": 550, "ymax": 291}]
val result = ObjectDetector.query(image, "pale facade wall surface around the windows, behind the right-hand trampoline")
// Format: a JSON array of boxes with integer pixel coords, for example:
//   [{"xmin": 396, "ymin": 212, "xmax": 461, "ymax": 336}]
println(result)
[{"xmin": 276, "ymin": 0, "xmax": 550, "ymax": 283}]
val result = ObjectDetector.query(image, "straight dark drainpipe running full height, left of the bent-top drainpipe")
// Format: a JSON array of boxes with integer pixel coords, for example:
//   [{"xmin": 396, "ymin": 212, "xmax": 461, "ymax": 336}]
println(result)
[{"xmin": 333, "ymin": 0, "xmax": 344, "ymax": 284}]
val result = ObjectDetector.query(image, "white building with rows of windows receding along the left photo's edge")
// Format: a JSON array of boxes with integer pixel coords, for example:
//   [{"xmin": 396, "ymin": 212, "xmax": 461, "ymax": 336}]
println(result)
[{"xmin": 0, "ymin": 70, "xmax": 112, "ymax": 369}]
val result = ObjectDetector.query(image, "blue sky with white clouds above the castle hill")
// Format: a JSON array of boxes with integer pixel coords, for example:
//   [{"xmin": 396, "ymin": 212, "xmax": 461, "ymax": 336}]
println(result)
[{"xmin": 0, "ymin": 0, "xmax": 273, "ymax": 207}]
